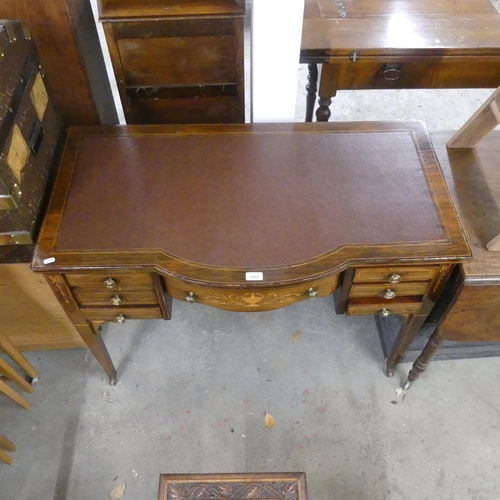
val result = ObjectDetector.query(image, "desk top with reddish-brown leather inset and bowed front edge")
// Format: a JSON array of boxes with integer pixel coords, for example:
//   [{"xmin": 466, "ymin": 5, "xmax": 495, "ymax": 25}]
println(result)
[{"xmin": 33, "ymin": 122, "xmax": 469, "ymax": 283}]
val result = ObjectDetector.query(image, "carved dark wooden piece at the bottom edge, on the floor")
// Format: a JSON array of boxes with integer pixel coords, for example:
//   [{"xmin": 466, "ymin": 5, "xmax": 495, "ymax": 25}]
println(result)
[{"xmin": 158, "ymin": 473, "xmax": 307, "ymax": 500}]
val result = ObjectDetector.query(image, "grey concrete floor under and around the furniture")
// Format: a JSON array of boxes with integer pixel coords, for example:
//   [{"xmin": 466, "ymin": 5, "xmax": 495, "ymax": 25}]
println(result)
[{"xmin": 0, "ymin": 74, "xmax": 500, "ymax": 500}]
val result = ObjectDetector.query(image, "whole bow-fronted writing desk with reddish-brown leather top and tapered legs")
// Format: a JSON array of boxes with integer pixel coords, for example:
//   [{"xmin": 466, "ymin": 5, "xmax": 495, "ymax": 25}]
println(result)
[{"xmin": 32, "ymin": 122, "xmax": 470, "ymax": 383}]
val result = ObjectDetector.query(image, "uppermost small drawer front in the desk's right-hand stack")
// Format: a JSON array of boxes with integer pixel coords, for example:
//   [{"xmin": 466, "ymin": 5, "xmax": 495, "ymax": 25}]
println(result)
[{"xmin": 353, "ymin": 266, "xmax": 439, "ymax": 284}]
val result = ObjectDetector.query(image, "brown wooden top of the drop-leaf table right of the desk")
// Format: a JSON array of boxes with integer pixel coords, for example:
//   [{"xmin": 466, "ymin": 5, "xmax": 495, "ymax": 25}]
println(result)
[{"xmin": 432, "ymin": 131, "xmax": 500, "ymax": 284}]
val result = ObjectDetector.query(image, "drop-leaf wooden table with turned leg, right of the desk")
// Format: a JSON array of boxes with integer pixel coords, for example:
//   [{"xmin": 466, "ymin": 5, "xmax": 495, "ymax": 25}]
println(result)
[{"xmin": 404, "ymin": 132, "xmax": 500, "ymax": 382}]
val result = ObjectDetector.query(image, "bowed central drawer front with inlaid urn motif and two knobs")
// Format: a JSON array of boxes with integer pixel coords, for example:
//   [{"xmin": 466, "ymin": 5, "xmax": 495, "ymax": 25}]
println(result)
[{"xmin": 165, "ymin": 275, "xmax": 338, "ymax": 311}]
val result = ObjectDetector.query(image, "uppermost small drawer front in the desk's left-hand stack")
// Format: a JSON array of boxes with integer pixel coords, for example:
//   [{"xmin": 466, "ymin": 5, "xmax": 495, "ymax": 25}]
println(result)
[{"xmin": 65, "ymin": 271, "xmax": 153, "ymax": 291}]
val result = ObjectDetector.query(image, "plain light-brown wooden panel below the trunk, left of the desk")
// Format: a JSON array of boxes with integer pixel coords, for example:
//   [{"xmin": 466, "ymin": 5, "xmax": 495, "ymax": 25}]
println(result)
[{"xmin": 0, "ymin": 263, "xmax": 84, "ymax": 351}]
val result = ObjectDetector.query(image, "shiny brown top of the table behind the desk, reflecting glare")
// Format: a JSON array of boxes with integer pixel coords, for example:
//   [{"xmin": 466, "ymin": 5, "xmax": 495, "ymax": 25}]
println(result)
[{"xmin": 301, "ymin": 0, "xmax": 500, "ymax": 56}]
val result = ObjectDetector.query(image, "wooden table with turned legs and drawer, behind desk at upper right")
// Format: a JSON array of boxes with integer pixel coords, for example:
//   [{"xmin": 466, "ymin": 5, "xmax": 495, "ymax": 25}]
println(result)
[{"xmin": 300, "ymin": 0, "xmax": 500, "ymax": 121}]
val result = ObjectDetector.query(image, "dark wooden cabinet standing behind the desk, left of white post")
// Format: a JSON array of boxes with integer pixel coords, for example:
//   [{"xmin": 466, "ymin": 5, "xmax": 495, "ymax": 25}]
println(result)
[{"xmin": 100, "ymin": 0, "xmax": 245, "ymax": 123}]
